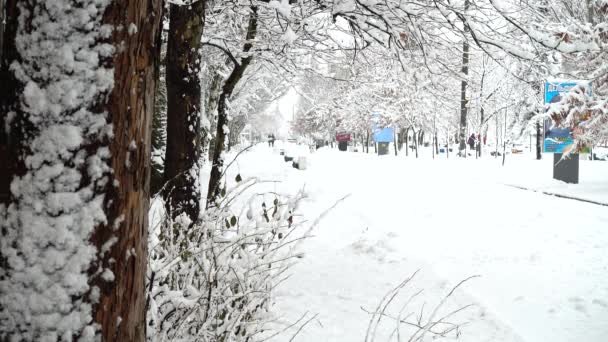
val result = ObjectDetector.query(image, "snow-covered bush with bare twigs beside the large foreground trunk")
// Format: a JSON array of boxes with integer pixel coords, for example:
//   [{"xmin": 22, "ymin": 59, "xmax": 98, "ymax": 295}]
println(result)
[{"xmin": 147, "ymin": 176, "xmax": 303, "ymax": 342}]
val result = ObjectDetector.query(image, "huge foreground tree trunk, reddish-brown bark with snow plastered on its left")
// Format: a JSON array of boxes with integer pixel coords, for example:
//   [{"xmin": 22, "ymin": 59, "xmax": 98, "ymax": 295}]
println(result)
[{"xmin": 0, "ymin": 0, "xmax": 162, "ymax": 341}]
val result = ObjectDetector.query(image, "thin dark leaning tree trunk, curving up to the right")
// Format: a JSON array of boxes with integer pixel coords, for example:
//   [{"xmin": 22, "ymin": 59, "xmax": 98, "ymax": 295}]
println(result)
[{"xmin": 207, "ymin": 6, "xmax": 258, "ymax": 207}]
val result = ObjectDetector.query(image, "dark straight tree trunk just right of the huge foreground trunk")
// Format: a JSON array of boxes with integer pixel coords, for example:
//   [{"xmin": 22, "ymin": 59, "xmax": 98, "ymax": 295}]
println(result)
[{"xmin": 164, "ymin": 0, "xmax": 205, "ymax": 221}]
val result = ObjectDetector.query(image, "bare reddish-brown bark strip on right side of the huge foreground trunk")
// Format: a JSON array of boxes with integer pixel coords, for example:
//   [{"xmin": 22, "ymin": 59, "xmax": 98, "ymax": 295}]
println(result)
[{"xmin": 91, "ymin": 0, "xmax": 162, "ymax": 341}]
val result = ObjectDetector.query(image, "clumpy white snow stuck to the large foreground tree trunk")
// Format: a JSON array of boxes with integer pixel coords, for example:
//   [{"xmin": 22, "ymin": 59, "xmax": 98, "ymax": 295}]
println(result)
[{"xmin": 0, "ymin": 0, "xmax": 114, "ymax": 341}]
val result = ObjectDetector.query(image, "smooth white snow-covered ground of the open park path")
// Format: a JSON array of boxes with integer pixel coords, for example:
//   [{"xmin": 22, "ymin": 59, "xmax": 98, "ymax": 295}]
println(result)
[{"xmin": 223, "ymin": 145, "xmax": 608, "ymax": 342}]
